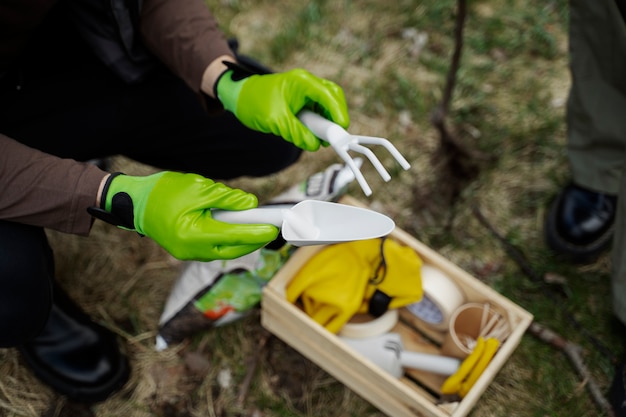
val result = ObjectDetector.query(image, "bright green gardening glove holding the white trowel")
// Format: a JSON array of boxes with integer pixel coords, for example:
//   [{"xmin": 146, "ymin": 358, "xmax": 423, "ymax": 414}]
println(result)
[{"xmin": 88, "ymin": 171, "xmax": 278, "ymax": 261}]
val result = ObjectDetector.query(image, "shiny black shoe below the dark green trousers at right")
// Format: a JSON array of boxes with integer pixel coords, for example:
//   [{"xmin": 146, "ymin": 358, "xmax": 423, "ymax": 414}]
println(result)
[{"xmin": 545, "ymin": 184, "xmax": 617, "ymax": 264}]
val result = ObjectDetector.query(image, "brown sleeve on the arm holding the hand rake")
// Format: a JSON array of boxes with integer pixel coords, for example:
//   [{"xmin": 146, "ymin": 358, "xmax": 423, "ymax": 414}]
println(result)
[{"xmin": 140, "ymin": 0, "xmax": 233, "ymax": 92}]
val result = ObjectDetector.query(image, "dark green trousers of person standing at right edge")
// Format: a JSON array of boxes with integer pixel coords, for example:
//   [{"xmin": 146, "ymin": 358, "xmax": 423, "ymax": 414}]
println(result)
[{"xmin": 567, "ymin": 0, "xmax": 626, "ymax": 323}]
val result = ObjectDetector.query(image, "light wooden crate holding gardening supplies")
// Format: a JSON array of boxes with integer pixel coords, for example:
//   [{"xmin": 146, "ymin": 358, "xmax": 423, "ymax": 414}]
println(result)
[{"xmin": 261, "ymin": 198, "xmax": 532, "ymax": 417}]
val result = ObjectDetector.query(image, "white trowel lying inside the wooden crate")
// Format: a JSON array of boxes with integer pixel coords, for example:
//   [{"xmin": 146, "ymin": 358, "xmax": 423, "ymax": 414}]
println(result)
[{"xmin": 341, "ymin": 333, "xmax": 461, "ymax": 378}]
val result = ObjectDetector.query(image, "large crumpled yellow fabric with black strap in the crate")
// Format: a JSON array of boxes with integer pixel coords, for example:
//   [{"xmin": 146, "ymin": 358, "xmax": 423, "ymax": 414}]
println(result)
[{"xmin": 286, "ymin": 239, "xmax": 422, "ymax": 333}]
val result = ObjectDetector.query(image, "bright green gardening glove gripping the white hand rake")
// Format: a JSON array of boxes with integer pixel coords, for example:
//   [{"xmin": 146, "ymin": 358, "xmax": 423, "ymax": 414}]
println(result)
[{"xmin": 215, "ymin": 62, "xmax": 350, "ymax": 151}]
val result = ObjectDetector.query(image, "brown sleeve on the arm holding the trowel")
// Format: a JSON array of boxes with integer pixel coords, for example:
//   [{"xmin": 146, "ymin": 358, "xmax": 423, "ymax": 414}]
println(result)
[{"xmin": 0, "ymin": 134, "xmax": 107, "ymax": 235}]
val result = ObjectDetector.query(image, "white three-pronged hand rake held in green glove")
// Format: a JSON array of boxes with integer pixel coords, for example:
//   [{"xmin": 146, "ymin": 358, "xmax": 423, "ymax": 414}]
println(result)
[{"xmin": 298, "ymin": 110, "xmax": 411, "ymax": 196}]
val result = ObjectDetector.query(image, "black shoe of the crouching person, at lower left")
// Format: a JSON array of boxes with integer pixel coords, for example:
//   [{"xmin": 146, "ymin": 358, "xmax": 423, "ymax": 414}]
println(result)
[{"xmin": 20, "ymin": 286, "xmax": 130, "ymax": 403}]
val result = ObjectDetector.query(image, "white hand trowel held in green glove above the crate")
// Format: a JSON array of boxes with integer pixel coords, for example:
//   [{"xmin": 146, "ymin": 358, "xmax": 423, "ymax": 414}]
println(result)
[{"xmin": 212, "ymin": 200, "xmax": 395, "ymax": 246}]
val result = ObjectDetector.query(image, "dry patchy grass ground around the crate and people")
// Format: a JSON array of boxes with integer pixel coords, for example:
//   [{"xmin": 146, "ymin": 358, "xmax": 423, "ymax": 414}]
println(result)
[{"xmin": 0, "ymin": 0, "xmax": 625, "ymax": 417}]
